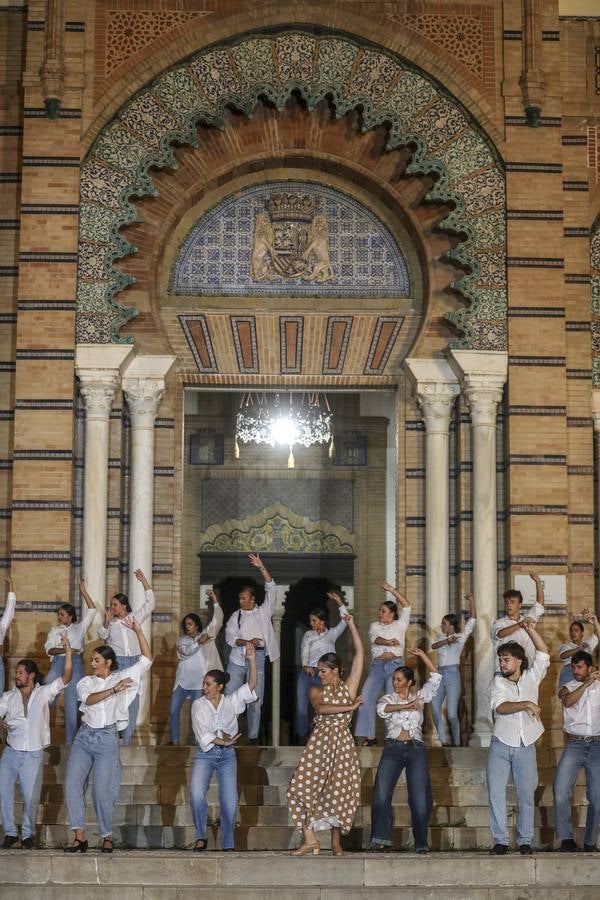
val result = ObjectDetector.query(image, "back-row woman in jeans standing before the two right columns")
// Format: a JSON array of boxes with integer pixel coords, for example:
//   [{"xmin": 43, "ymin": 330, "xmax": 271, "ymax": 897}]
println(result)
[{"xmin": 431, "ymin": 594, "xmax": 477, "ymax": 747}]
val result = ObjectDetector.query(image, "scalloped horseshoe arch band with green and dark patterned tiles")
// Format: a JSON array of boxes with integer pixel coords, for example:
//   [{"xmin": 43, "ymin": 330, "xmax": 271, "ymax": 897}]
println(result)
[{"xmin": 77, "ymin": 30, "xmax": 507, "ymax": 350}]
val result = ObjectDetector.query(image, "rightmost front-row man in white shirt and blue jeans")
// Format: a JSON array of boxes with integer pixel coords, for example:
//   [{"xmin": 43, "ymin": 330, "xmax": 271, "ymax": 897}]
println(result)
[{"xmin": 554, "ymin": 616, "xmax": 600, "ymax": 853}]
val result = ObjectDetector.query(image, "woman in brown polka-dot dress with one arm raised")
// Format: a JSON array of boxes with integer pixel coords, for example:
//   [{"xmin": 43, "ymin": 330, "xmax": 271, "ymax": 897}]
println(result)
[{"xmin": 287, "ymin": 616, "xmax": 364, "ymax": 856}]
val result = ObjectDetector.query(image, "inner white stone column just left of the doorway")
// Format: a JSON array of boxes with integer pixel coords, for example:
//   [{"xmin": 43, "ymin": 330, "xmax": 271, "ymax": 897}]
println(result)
[{"xmin": 123, "ymin": 356, "xmax": 175, "ymax": 726}]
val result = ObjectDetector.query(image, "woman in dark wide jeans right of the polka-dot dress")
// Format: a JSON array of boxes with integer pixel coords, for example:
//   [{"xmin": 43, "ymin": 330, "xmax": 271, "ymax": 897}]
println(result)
[{"xmin": 371, "ymin": 649, "xmax": 442, "ymax": 853}]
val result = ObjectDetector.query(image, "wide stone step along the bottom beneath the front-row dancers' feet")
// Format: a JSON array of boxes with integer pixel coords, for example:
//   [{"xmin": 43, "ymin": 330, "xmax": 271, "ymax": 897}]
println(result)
[{"xmin": 0, "ymin": 850, "xmax": 600, "ymax": 900}]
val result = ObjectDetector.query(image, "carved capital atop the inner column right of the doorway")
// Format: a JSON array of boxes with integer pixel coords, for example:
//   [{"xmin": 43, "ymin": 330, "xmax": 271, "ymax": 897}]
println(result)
[{"xmin": 404, "ymin": 359, "xmax": 460, "ymax": 434}]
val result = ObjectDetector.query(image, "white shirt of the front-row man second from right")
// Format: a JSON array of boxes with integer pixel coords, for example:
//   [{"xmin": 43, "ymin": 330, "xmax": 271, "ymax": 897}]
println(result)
[{"xmin": 490, "ymin": 650, "xmax": 550, "ymax": 747}]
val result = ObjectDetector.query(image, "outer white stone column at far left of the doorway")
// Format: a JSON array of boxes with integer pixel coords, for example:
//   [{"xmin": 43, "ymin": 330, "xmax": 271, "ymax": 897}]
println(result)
[{"xmin": 75, "ymin": 344, "xmax": 133, "ymax": 622}]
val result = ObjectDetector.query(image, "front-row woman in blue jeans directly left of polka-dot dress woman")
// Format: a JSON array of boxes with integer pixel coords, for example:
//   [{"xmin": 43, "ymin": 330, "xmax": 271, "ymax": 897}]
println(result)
[{"xmin": 190, "ymin": 641, "xmax": 258, "ymax": 851}]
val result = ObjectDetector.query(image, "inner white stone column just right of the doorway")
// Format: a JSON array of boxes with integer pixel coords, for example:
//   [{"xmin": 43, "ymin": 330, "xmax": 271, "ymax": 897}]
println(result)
[{"xmin": 405, "ymin": 359, "xmax": 460, "ymax": 634}]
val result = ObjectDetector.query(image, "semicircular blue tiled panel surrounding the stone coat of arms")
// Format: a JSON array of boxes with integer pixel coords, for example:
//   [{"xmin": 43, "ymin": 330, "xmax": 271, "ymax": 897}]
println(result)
[{"xmin": 169, "ymin": 181, "xmax": 410, "ymax": 297}]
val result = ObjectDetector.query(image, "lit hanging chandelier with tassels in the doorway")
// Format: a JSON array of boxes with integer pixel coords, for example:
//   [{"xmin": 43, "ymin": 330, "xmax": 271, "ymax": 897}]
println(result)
[{"xmin": 235, "ymin": 391, "xmax": 333, "ymax": 469}]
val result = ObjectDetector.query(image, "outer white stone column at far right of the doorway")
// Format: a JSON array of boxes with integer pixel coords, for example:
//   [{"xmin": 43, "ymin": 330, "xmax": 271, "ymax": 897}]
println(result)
[{"xmin": 450, "ymin": 350, "xmax": 508, "ymax": 747}]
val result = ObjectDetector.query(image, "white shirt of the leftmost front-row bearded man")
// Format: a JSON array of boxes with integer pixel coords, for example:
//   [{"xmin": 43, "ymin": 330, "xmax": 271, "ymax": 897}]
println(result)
[{"xmin": 0, "ymin": 678, "xmax": 65, "ymax": 750}]
